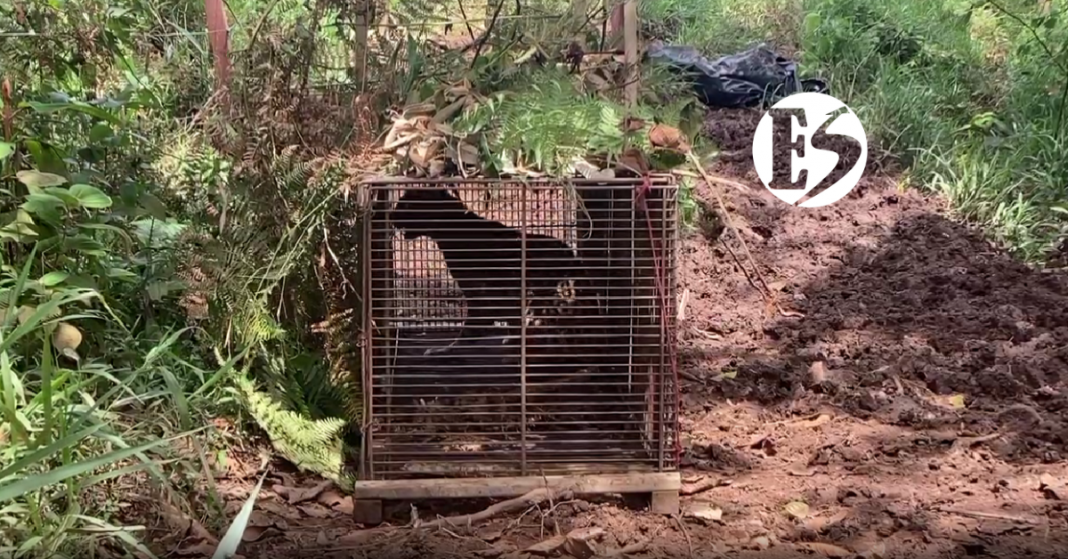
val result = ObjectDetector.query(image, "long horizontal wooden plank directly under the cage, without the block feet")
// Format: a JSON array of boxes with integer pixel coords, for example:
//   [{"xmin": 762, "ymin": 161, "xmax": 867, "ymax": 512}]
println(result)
[{"xmin": 352, "ymin": 471, "xmax": 682, "ymax": 500}]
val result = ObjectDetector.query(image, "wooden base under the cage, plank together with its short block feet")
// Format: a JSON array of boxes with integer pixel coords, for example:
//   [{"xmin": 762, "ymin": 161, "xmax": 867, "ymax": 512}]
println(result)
[{"xmin": 352, "ymin": 471, "xmax": 682, "ymax": 526}]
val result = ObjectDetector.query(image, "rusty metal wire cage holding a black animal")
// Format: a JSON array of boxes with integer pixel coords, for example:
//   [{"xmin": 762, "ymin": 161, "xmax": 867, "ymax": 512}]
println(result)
[{"xmin": 360, "ymin": 176, "xmax": 678, "ymax": 480}]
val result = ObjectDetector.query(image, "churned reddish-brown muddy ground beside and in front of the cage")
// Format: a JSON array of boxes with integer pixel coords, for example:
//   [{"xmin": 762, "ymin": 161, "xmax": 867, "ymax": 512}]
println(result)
[{"xmin": 131, "ymin": 111, "xmax": 1068, "ymax": 559}]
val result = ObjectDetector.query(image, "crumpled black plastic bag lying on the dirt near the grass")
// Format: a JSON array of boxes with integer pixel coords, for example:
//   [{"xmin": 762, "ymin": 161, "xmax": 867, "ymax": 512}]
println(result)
[{"xmin": 645, "ymin": 43, "xmax": 827, "ymax": 108}]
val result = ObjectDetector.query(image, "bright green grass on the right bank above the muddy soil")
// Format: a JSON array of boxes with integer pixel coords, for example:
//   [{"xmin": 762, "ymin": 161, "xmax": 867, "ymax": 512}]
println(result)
[{"xmin": 642, "ymin": 0, "xmax": 1068, "ymax": 262}]
